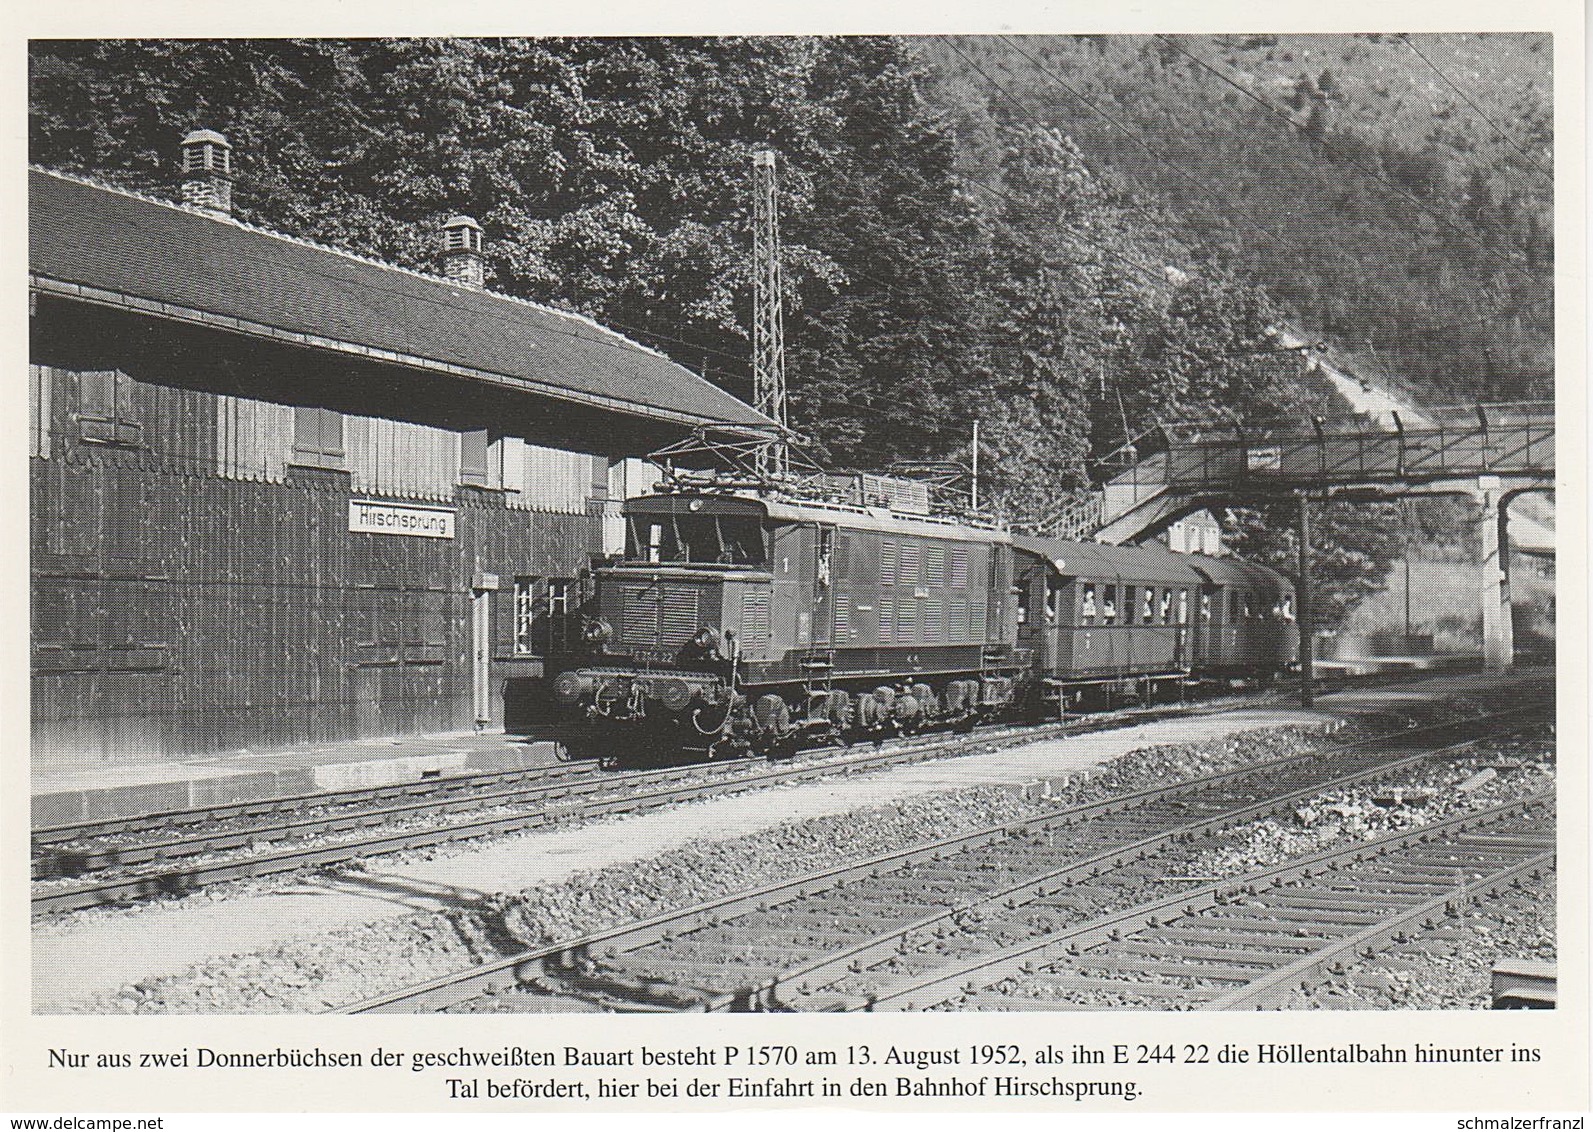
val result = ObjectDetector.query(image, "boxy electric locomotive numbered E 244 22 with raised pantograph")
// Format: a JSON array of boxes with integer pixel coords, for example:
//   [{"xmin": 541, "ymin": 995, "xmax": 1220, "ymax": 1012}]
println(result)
[{"xmin": 553, "ymin": 489, "xmax": 1031, "ymax": 758}]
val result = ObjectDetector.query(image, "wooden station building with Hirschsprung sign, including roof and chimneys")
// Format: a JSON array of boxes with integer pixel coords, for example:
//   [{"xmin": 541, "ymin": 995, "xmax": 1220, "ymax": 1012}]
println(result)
[{"xmin": 29, "ymin": 131, "xmax": 769, "ymax": 767}]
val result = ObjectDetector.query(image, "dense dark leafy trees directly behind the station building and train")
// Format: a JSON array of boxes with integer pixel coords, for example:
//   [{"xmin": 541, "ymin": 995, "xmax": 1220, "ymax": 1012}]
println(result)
[{"xmin": 30, "ymin": 38, "xmax": 1306, "ymax": 516}]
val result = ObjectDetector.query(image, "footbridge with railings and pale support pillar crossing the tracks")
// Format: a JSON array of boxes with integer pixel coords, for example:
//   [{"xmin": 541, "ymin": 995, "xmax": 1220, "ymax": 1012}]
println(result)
[{"xmin": 1048, "ymin": 401, "xmax": 1555, "ymax": 669}]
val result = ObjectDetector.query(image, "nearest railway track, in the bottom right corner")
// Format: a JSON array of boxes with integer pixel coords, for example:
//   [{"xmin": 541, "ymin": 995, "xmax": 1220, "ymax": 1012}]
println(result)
[{"xmin": 853, "ymin": 794, "xmax": 1555, "ymax": 1009}]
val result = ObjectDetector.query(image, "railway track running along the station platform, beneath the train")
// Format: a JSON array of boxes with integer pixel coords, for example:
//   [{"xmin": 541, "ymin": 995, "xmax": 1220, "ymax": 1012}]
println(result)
[{"xmin": 32, "ymin": 687, "xmax": 1319, "ymax": 914}]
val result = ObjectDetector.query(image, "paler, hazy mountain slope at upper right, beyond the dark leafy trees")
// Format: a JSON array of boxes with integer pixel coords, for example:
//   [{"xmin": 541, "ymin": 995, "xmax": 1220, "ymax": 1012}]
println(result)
[{"xmin": 921, "ymin": 35, "xmax": 1553, "ymax": 404}]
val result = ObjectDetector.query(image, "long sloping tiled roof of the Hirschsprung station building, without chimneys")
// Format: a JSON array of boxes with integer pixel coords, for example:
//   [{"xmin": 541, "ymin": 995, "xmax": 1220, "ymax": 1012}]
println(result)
[{"xmin": 29, "ymin": 169, "xmax": 773, "ymax": 430}]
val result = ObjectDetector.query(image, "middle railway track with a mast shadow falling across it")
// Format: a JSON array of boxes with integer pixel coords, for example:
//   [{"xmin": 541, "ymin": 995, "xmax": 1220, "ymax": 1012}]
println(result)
[{"xmin": 347, "ymin": 704, "xmax": 1537, "ymax": 1013}]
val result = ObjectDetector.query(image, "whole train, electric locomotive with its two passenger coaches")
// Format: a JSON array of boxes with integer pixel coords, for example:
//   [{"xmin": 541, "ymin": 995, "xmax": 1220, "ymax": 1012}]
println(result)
[{"xmin": 551, "ymin": 478, "xmax": 1298, "ymax": 759}]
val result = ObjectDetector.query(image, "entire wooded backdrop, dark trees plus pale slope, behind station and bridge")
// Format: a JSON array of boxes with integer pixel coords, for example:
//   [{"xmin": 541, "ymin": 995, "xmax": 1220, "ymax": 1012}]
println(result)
[{"xmin": 29, "ymin": 37, "xmax": 1552, "ymax": 627}]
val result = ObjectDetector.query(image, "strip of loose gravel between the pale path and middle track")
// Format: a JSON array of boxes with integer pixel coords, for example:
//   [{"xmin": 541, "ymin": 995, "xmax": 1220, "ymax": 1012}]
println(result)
[{"xmin": 52, "ymin": 699, "xmax": 1529, "ymax": 1014}]
